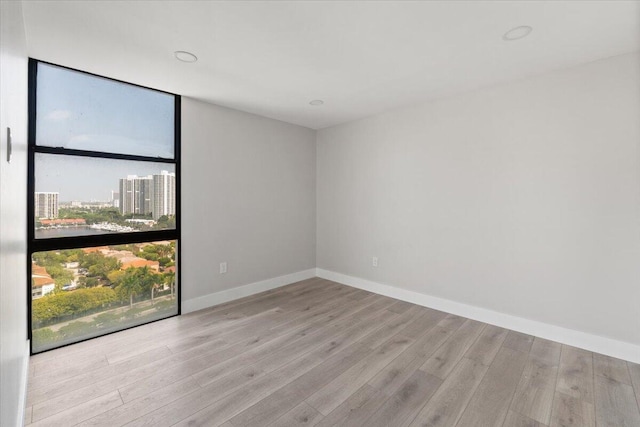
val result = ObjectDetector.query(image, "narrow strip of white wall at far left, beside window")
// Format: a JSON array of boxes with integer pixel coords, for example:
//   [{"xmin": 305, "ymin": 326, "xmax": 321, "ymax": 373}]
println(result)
[{"xmin": 0, "ymin": 1, "xmax": 28, "ymax": 426}]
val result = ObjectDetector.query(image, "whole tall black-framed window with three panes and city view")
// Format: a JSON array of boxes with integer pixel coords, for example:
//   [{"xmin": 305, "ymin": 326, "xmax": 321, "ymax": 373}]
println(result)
[{"xmin": 27, "ymin": 59, "xmax": 180, "ymax": 354}]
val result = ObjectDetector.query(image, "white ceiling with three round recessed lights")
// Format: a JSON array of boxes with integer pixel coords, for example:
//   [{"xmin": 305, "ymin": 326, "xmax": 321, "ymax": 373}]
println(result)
[{"xmin": 23, "ymin": 0, "xmax": 640, "ymax": 129}]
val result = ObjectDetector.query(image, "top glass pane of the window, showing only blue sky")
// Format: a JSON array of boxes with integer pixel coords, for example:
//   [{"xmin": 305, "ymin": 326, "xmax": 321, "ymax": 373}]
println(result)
[{"xmin": 36, "ymin": 63, "xmax": 175, "ymax": 158}]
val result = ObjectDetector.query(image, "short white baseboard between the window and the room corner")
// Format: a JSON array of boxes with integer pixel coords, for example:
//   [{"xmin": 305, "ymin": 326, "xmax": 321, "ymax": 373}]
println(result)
[{"xmin": 182, "ymin": 268, "xmax": 316, "ymax": 314}]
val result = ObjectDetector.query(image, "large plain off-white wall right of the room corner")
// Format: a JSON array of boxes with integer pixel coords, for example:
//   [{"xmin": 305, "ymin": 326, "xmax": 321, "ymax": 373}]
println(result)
[{"xmin": 317, "ymin": 54, "xmax": 640, "ymax": 352}]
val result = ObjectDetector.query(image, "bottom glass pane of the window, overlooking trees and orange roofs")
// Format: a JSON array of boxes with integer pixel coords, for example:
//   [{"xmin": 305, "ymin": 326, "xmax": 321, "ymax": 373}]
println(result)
[{"xmin": 31, "ymin": 241, "xmax": 178, "ymax": 353}]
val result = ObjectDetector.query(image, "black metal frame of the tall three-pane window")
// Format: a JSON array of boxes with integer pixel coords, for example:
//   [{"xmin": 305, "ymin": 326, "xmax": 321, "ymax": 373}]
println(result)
[{"xmin": 27, "ymin": 58, "xmax": 182, "ymax": 355}]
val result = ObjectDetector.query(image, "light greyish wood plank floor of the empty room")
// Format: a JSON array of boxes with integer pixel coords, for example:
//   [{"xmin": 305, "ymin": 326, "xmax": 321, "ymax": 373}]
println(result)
[{"xmin": 25, "ymin": 279, "xmax": 640, "ymax": 427}]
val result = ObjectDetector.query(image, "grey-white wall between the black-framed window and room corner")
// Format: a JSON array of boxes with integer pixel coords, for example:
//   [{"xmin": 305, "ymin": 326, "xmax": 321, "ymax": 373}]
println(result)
[{"xmin": 181, "ymin": 97, "xmax": 316, "ymax": 311}]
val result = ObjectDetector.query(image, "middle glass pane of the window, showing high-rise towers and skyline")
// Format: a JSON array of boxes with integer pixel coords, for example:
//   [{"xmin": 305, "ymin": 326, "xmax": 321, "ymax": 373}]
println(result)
[{"xmin": 34, "ymin": 153, "xmax": 176, "ymax": 239}]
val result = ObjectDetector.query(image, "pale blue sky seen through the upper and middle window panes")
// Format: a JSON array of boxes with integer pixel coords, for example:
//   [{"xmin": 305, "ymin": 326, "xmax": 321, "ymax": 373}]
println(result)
[{"xmin": 35, "ymin": 63, "xmax": 175, "ymax": 201}]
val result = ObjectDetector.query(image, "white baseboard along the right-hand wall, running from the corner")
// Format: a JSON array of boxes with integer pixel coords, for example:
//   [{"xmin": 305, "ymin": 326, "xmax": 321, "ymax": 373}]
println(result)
[{"xmin": 316, "ymin": 268, "xmax": 640, "ymax": 363}]
